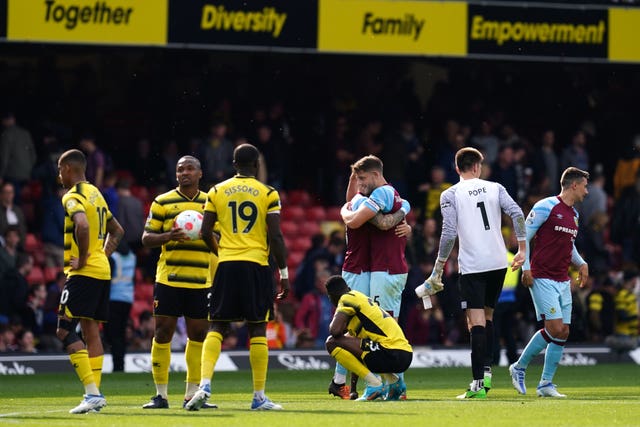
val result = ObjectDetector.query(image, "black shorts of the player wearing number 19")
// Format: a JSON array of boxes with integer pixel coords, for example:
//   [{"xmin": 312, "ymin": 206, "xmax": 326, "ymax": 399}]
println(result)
[{"xmin": 209, "ymin": 261, "xmax": 275, "ymax": 322}]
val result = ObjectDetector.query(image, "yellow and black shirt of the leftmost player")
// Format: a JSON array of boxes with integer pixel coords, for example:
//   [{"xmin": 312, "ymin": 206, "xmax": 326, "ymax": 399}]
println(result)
[{"xmin": 62, "ymin": 182, "xmax": 112, "ymax": 280}]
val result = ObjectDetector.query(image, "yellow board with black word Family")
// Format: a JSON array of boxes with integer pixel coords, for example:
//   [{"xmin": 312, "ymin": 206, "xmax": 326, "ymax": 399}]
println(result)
[{"xmin": 318, "ymin": 0, "xmax": 467, "ymax": 56}]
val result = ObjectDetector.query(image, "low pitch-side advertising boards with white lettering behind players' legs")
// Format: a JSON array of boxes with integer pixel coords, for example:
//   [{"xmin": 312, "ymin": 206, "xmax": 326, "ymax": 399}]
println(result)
[{"xmin": 0, "ymin": 346, "xmax": 640, "ymax": 376}]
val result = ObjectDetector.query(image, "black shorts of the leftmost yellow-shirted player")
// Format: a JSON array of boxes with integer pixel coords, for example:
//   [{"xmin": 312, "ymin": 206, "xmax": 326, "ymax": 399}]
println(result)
[{"xmin": 58, "ymin": 275, "xmax": 111, "ymax": 322}]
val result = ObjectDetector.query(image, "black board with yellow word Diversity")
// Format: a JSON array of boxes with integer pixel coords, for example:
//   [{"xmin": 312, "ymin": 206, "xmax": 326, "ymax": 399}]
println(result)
[{"xmin": 168, "ymin": 0, "xmax": 318, "ymax": 50}]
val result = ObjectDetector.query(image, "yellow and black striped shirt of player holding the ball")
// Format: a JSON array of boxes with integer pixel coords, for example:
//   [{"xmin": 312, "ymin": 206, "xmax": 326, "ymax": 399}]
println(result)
[{"xmin": 144, "ymin": 188, "xmax": 213, "ymax": 288}]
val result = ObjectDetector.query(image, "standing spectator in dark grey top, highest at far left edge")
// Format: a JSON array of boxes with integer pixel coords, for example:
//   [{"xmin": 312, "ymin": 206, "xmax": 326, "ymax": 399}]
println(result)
[{"xmin": 0, "ymin": 112, "xmax": 36, "ymax": 204}]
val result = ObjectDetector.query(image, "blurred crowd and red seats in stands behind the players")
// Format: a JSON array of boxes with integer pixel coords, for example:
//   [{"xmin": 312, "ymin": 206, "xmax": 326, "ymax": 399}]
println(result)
[{"xmin": 0, "ymin": 54, "xmax": 640, "ymax": 358}]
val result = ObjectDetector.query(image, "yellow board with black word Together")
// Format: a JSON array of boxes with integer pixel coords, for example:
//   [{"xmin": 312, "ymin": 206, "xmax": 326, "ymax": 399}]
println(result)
[{"xmin": 7, "ymin": 0, "xmax": 168, "ymax": 45}]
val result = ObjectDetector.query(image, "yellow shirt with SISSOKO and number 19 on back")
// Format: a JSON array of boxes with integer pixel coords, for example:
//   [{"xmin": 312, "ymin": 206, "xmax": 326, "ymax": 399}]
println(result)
[{"xmin": 205, "ymin": 175, "xmax": 280, "ymax": 265}]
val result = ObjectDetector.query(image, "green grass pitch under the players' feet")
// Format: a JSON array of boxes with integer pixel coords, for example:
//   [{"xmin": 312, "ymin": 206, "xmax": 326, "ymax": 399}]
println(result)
[{"xmin": 0, "ymin": 364, "xmax": 640, "ymax": 427}]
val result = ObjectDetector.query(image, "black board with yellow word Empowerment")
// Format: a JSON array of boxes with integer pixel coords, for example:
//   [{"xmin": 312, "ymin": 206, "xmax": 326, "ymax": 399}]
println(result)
[{"xmin": 467, "ymin": 5, "xmax": 610, "ymax": 59}]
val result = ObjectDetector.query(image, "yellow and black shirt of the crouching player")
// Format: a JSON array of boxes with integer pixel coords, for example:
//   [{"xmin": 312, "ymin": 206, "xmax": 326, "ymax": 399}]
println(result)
[{"xmin": 336, "ymin": 291, "xmax": 413, "ymax": 351}]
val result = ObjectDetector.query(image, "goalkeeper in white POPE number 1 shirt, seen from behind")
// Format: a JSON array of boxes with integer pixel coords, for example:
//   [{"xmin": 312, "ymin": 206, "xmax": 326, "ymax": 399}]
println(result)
[{"xmin": 416, "ymin": 147, "xmax": 526, "ymax": 399}]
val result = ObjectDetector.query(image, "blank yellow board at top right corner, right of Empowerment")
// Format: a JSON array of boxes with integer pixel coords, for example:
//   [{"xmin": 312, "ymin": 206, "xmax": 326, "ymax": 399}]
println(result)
[{"xmin": 609, "ymin": 7, "xmax": 640, "ymax": 62}]
